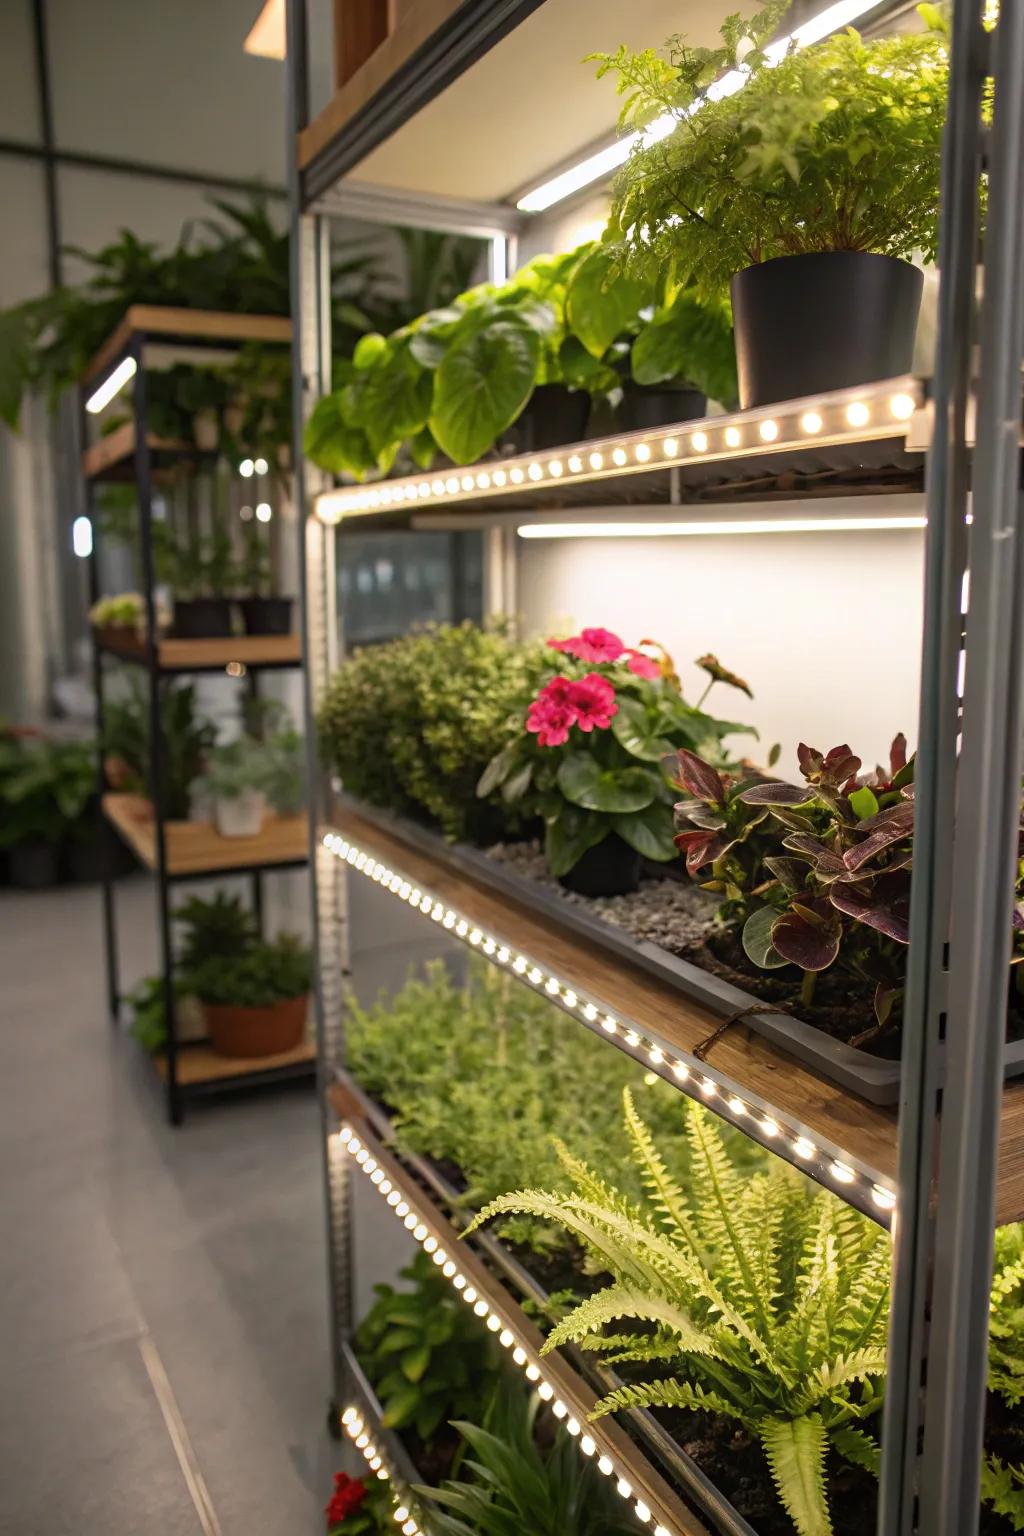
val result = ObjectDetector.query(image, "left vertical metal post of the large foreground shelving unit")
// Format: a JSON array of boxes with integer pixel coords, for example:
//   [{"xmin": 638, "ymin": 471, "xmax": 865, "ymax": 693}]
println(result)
[{"xmin": 286, "ymin": 0, "xmax": 352, "ymax": 1433}]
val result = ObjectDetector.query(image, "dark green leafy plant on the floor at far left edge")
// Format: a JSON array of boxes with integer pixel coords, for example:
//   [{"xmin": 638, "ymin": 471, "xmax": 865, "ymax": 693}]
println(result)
[{"xmin": 0, "ymin": 727, "xmax": 97, "ymax": 848}]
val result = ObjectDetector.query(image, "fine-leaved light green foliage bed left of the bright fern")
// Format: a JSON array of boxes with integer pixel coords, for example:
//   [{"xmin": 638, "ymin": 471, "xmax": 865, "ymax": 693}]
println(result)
[{"xmin": 345, "ymin": 960, "xmax": 760, "ymax": 1253}]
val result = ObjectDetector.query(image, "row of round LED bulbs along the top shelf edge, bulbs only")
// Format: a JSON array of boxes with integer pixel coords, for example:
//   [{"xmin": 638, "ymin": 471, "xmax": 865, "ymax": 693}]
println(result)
[{"xmin": 328, "ymin": 392, "xmax": 917, "ymax": 507}]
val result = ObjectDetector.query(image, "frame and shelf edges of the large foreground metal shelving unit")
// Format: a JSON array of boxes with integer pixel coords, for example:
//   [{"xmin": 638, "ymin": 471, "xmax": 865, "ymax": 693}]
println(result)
[{"xmin": 289, "ymin": 0, "xmax": 1024, "ymax": 1536}]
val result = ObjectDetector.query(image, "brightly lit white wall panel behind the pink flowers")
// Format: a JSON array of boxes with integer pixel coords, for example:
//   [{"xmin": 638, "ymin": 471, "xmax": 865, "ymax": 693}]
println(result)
[{"xmin": 517, "ymin": 496, "xmax": 924, "ymax": 774}]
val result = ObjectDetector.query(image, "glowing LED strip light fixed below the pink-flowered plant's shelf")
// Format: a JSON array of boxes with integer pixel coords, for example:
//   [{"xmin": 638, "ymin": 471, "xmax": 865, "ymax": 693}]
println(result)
[{"xmin": 321, "ymin": 833, "xmax": 897, "ymax": 1226}]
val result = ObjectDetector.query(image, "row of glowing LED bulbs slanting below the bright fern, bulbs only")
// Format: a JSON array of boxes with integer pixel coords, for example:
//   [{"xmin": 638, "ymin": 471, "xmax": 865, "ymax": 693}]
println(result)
[{"xmin": 338, "ymin": 1124, "xmax": 672, "ymax": 1536}]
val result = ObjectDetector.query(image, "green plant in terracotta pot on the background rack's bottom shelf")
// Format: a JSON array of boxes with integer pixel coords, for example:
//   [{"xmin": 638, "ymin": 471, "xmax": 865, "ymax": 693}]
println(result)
[{"xmin": 189, "ymin": 934, "xmax": 312, "ymax": 1057}]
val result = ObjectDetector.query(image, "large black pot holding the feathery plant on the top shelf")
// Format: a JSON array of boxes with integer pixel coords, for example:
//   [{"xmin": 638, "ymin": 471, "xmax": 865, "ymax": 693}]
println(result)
[{"xmin": 731, "ymin": 250, "xmax": 924, "ymax": 410}]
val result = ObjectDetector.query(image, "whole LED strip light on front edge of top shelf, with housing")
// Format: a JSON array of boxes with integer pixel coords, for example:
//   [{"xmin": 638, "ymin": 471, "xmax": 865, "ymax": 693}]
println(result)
[{"xmin": 316, "ymin": 375, "xmax": 924, "ymax": 524}]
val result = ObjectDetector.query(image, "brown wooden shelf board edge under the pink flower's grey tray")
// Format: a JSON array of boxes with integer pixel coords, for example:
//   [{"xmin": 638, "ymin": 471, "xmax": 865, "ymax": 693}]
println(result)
[{"xmin": 330, "ymin": 806, "xmax": 1024, "ymax": 1223}]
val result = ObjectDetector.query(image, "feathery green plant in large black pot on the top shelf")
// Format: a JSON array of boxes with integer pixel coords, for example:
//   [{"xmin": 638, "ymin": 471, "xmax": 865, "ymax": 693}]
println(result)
[{"xmin": 591, "ymin": 5, "xmax": 949, "ymax": 407}]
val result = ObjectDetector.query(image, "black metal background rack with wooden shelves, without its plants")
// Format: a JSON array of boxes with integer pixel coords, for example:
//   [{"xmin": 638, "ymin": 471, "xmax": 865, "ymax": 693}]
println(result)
[{"xmin": 78, "ymin": 304, "xmax": 315, "ymax": 1124}]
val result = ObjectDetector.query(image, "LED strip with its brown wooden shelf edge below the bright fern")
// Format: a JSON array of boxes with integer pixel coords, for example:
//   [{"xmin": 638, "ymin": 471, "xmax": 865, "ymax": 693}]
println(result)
[{"xmin": 336, "ymin": 1121, "xmax": 693, "ymax": 1536}]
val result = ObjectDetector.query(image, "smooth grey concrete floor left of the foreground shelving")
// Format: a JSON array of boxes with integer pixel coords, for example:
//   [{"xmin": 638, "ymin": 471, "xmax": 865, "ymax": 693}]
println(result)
[{"xmin": 0, "ymin": 880, "xmax": 339, "ymax": 1536}]
